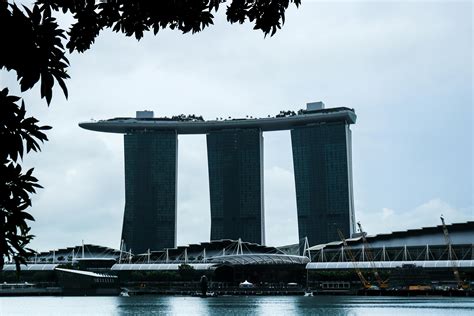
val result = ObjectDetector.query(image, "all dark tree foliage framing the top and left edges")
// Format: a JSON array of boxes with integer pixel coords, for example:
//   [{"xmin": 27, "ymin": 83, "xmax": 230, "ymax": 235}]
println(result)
[{"xmin": 0, "ymin": 0, "xmax": 301, "ymax": 269}]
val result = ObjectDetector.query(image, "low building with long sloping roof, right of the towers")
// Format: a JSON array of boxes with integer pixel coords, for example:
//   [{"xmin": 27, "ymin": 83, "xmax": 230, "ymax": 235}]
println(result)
[{"xmin": 306, "ymin": 222, "xmax": 474, "ymax": 288}]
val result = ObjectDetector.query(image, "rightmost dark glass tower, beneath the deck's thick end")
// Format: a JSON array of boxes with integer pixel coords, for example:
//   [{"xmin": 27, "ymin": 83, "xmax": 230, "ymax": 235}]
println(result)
[{"xmin": 291, "ymin": 121, "xmax": 354, "ymax": 246}]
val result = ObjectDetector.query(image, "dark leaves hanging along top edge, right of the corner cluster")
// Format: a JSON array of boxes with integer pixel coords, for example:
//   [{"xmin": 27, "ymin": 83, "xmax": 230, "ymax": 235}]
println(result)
[{"xmin": 37, "ymin": 0, "xmax": 301, "ymax": 52}]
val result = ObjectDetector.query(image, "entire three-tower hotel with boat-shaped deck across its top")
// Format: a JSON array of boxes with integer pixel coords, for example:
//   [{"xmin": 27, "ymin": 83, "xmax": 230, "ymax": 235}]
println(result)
[{"xmin": 79, "ymin": 102, "xmax": 356, "ymax": 253}]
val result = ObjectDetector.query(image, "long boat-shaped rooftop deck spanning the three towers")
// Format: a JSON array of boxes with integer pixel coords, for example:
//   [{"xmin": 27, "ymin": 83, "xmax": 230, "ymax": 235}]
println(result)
[{"xmin": 79, "ymin": 107, "xmax": 357, "ymax": 134}]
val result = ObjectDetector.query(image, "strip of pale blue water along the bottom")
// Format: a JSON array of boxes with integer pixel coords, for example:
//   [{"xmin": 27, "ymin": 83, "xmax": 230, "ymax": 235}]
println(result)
[{"xmin": 0, "ymin": 296, "xmax": 474, "ymax": 316}]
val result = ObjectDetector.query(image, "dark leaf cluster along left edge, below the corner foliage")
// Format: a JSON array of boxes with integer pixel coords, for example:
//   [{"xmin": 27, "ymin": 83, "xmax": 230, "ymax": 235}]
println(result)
[{"xmin": 0, "ymin": 88, "xmax": 51, "ymax": 269}]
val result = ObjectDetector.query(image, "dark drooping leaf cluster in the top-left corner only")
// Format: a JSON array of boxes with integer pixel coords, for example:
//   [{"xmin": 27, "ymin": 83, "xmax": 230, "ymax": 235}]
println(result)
[{"xmin": 0, "ymin": 2, "xmax": 69, "ymax": 104}]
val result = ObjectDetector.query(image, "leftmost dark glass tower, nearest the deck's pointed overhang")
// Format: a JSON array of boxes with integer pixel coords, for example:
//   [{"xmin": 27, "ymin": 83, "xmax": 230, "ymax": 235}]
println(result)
[{"xmin": 122, "ymin": 131, "xmax": 178, "ymax": 253}]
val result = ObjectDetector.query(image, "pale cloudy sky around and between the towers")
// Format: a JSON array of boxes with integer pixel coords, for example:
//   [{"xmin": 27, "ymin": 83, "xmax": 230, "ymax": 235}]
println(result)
[{"xmin": 0, "ymin": 1, "xmax": 474, "ymax": 251}]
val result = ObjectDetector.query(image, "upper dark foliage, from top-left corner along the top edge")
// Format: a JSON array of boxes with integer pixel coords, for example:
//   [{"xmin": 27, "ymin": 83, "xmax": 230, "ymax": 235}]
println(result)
[{"xmin": 0, "ymin": 0, "xmax": 301, "ymax": 104}]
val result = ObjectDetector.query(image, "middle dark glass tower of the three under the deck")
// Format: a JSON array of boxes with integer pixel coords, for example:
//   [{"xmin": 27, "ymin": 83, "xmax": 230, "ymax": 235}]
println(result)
[{"xmin": 207, "ymin": 129, "xmax": 265, "ymax": 244}]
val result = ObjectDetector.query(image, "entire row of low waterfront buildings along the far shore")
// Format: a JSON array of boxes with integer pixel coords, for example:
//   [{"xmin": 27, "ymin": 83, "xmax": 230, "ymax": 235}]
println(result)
[{"xmin": 5, "ymin": 221, "xmax": 474, "ymax": 294}]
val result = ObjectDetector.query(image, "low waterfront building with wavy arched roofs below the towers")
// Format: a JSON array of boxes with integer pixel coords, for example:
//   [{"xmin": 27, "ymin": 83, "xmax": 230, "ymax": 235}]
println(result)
[{"xmin": 6, "ymin": 239, "xmax": 309, "ymax": 288}]
